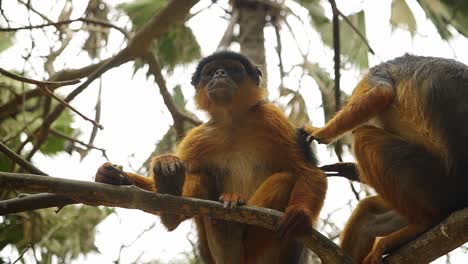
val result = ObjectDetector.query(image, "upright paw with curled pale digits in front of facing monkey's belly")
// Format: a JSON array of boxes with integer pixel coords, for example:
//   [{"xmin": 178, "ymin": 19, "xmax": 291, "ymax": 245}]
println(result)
[{"xmin": 151, "ymin": 155, "xmax": 185, "ymax": 196}]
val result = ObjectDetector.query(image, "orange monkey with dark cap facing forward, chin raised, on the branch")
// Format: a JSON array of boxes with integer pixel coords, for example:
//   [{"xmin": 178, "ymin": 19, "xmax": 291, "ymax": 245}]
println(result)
[{"xmin": 96, "ymin": 51, "xmax": 327, "ymax": 263}]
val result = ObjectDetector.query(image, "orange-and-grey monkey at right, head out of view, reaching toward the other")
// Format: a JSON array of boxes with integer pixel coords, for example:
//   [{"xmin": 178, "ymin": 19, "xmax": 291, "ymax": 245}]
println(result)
[{"xmin": 305, "ymin": 55, "xmax": 468, "ymax": 264}]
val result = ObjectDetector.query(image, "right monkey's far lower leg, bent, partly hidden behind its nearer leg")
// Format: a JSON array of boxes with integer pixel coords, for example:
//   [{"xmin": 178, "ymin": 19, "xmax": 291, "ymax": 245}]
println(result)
[{"xmin": 340, "ymin": 196, "xmax": 407, "ymax": 263}]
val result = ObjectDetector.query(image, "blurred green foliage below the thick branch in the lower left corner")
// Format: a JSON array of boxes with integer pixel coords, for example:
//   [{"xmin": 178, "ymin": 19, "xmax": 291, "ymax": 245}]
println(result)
[{"xmin": 0, "ymin": 206, "xmax": 113, "ymax": 264}]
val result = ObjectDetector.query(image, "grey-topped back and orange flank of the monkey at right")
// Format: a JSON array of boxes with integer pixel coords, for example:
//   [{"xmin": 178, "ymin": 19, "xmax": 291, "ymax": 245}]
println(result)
[{"xmin": 368, "ymin": 54, "xmax": 468, "ymax": 211}]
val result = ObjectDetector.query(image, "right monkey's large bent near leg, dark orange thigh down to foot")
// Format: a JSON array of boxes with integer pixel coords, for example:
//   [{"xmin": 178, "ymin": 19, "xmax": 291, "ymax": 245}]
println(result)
[{"xmin": 354, "ymin": 126, "xmax": 451, "ymax": 263}]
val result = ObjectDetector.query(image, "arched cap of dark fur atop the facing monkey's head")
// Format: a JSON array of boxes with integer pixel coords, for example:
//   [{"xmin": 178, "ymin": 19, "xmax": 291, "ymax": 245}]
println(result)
[{"xmin": 192, "ymin": 50, "xmax": 262, "ymax": 87}]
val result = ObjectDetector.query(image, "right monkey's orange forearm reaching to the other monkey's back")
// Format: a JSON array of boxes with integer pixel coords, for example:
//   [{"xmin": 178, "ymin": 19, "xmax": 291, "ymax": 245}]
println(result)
[{"xmin": 304, "ymin": 84, "xmax": 394, "ymax": 143}]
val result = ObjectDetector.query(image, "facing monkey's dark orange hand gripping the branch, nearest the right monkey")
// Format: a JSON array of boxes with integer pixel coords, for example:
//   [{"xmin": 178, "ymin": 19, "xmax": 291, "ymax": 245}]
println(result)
[{"xmin": 276, "ymin": 205, "xmax": 312, "ymax": 240}]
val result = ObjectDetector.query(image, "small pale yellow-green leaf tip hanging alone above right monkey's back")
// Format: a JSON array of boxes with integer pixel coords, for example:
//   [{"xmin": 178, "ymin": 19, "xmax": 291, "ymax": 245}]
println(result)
[{"xmin": 390, "ymin": 0, "xmax": 416, "ymax": 36}]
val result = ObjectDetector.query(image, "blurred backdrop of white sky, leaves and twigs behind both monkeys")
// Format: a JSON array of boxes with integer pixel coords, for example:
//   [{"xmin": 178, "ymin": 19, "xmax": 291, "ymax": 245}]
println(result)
[{"xmin": 0, "ymin": 0, "xmax": 468, "ymax": 263}]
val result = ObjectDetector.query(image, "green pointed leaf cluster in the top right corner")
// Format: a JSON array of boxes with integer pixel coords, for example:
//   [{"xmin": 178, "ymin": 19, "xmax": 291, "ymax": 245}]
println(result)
[{"xmin": 418, "ymin": 0, "xmax": 468, "ymax": 40}]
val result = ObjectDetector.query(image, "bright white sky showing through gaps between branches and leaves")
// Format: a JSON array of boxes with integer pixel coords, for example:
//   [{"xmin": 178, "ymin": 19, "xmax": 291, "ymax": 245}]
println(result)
[{"xmin": 0, "ymin": 0, "xmax": 468, "ymax": 263}]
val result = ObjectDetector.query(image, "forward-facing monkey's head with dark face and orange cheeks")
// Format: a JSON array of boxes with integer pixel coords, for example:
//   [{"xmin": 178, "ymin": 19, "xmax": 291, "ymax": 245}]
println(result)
[{"xmin": 192, "ymin": 51, "xmax": 263, "ymax": 112}]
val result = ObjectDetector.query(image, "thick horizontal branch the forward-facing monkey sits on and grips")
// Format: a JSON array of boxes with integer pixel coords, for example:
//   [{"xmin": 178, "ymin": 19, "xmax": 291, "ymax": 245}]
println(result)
[{"xmin": 0, "ymin": 172, "xmax": 353, "ymax": 263}]
